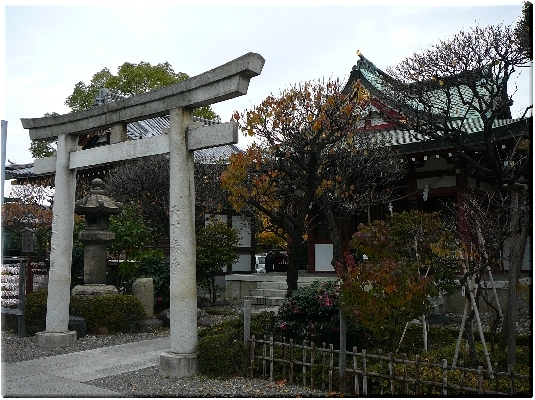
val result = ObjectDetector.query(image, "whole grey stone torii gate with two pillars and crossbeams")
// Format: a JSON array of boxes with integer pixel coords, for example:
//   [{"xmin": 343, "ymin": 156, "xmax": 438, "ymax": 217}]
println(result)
[{"xmin": 21, "ymin": 53, "xmax": 265, "ymax": 377}]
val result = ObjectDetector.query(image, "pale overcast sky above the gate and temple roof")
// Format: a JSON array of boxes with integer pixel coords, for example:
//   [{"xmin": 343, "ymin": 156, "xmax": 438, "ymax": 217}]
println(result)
[{"xmin": 0, "ymin": 0, "xmax": 532, "ymax": 167}]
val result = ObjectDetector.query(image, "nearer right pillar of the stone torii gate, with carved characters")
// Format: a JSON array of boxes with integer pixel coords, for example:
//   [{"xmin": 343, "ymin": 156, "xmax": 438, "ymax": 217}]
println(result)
[{"xmin": 159, "ymin": 108, "xmax": 197, "ymax": 377}]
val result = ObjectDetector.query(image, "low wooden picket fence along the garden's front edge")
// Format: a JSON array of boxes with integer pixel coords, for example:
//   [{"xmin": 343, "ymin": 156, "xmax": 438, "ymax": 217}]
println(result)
[{"xmin": 248, "ymin": 336, "xmax": 532, "ymax": 396}]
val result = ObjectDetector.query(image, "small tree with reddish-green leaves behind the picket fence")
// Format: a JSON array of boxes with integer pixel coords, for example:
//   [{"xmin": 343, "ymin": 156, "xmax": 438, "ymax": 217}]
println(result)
[{"xmin": 336, "ymin": 211, "xmax": 460, "ymax": 351}]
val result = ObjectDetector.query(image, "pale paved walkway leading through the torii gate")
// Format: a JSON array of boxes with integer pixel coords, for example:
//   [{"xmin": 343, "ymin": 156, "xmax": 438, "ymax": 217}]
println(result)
[{"xmin": 2, "ymin": 337, "xmax": 171, "ymax": 397}]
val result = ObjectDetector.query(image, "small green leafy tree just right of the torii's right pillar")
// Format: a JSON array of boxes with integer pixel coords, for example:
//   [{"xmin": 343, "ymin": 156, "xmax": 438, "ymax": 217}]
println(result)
[{"xmin": 196, "ymin": 221, "xmax": 240, "ymax": 303}]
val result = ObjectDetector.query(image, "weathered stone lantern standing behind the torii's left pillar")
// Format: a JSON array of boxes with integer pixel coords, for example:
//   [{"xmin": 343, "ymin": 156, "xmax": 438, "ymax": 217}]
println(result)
[{"xmin": 72, "ymin": 179, "xmax": 121, "ymax": 296}]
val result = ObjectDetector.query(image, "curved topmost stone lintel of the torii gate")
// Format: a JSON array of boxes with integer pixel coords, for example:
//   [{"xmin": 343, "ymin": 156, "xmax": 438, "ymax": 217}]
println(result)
[{"xmin": 21, "ymin": 53, "xmax": 265, "ymax": 140}]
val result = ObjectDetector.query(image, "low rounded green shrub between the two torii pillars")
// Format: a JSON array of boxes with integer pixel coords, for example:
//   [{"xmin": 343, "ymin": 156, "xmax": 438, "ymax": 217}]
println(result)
[{"xmin": 70, "ymin": 294, "xmax": 149, "ymax": 333}]
